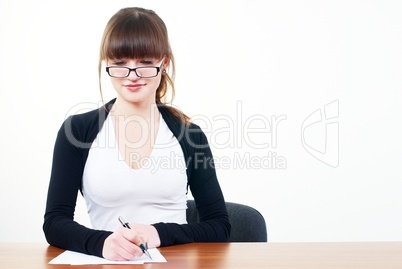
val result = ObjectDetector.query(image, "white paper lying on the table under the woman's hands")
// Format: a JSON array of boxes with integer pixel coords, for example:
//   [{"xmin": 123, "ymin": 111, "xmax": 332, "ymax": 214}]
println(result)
[{"xmin": 49, "ymin": 248, "xmax": 166, "ymax": 265}]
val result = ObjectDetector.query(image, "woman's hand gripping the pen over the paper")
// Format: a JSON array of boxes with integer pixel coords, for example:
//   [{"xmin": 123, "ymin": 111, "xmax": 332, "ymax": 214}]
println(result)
[{"xmin": 102, "ymin": 227, "xmax": 148, "ymax": 261}]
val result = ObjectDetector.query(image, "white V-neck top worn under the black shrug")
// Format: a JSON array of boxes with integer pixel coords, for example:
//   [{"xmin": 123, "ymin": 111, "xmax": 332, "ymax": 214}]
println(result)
[{"xmin": 82, "ymin": 113, "xmax": 187, "ymax": 231}]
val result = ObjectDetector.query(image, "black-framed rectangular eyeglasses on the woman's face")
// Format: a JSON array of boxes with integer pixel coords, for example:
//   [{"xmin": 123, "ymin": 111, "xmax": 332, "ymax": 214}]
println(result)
[{"xmin": 106, "ymin": 60, "xmax": 163, "ymax": 78}]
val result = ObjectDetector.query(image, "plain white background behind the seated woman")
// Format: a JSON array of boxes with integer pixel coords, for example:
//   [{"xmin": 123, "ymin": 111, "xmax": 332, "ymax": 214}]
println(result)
[{"xmin": 0, "ymin": 0, "xmax": 402, "ymax": 242}]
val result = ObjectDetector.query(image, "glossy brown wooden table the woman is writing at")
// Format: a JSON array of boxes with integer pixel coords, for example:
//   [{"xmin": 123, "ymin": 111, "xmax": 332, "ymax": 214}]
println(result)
[{"xmin": 0, "ymin": 242, "xmax": 402, "ymax": 269}]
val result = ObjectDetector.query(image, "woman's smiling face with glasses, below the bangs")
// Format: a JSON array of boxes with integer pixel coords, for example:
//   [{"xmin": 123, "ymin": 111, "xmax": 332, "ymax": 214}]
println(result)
[{"xmin": 106, "ymin": 58, "xmax": 165, "ymax": 104}]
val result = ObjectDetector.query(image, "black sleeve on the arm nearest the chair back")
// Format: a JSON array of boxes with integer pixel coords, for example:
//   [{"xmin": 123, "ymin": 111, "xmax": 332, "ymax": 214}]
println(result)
[{"xmin": 154, "ymin": 124, "xmax": 230, "ymax": 246}]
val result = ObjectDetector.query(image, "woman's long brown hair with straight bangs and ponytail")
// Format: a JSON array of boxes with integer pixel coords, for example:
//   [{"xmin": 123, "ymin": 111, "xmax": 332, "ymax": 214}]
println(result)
[{"xmin": 98, "ymin": 7, "xmax": 189, "ymax": 123}]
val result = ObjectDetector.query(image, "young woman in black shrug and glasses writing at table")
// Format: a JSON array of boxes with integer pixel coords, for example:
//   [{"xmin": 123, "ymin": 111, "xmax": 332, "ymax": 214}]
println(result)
[{"xmin": 43, "ymin": 7, "xmax": 230, "ymax": 260}]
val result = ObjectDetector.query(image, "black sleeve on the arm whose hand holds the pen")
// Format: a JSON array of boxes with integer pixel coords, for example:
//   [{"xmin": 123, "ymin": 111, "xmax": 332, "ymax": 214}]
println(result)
[{"xmin": 43, "ymin": 118, "xmax": 111, "ymax": 257}]
